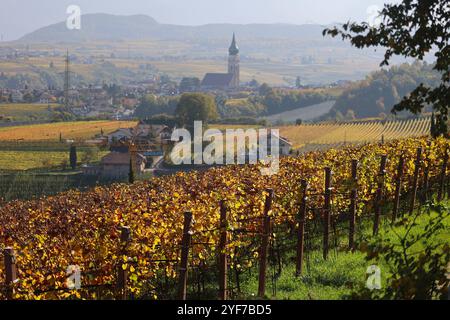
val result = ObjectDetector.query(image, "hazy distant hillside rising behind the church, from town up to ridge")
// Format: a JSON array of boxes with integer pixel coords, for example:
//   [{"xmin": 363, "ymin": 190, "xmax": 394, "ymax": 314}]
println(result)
[{"xmin": 0, "ymin": 14, "xmax": 396, "ymax": 88}]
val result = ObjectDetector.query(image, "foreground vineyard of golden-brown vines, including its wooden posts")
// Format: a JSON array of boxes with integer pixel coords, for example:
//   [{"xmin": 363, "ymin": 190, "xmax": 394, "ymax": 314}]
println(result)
[{"xmin": 0, "ymin": 136, "xmax": 450, "ymax": 299}]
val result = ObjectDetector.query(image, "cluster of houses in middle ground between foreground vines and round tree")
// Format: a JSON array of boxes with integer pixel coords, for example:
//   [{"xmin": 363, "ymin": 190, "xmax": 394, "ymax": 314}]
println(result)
[{"xmin": 81, "ymin": 120, "xmax": 292, "ymax": 179}]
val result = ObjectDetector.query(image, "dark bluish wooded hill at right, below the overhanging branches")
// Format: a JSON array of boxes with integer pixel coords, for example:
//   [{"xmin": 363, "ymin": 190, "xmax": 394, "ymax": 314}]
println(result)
[{"xmin": 328, "ymin": 62, "xmax": 439, "ymax": 120}]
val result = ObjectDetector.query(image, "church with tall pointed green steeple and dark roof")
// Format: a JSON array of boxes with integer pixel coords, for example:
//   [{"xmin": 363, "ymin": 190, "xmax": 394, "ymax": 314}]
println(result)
[{"xmin": 201, "ymin": 33, "xmax": 240, "ymax": 91}]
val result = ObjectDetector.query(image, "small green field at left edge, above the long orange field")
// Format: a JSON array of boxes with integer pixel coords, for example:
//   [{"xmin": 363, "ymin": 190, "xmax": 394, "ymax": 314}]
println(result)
[{"xmin": 0, "ymin": 103, "xmax": 56, "ymax": 122}]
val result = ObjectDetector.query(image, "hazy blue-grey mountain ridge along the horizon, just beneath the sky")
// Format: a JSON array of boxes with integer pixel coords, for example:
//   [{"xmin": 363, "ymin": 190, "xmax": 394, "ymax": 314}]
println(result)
[{"xmin": 20, "ymin": 13, "xmax": 335, "ymax": 42}]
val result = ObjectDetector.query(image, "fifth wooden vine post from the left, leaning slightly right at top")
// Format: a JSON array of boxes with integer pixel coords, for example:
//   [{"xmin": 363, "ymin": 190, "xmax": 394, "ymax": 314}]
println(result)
[{"xmin": 258, "ymin": 189, "xmax": 273, "ymax": 298}]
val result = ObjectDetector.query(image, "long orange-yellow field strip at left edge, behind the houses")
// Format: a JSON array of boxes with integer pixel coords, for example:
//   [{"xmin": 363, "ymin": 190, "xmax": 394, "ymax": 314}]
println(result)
[{"xmin": 0, "ymin": 121, "xmax": 136, "ymax": 141}]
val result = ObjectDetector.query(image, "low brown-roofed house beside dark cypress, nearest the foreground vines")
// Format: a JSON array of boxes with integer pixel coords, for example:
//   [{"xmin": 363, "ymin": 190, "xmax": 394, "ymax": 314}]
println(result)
[{"xmin": 100, "ymin": 152, "xmax": 147, "ymax": 178}]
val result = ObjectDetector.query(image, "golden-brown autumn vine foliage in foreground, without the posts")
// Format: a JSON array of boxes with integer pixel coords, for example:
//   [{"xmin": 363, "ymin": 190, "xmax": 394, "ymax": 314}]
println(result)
[{"xmin": 0, "ymin": 138, "xmax": 450, "ymax": 299}]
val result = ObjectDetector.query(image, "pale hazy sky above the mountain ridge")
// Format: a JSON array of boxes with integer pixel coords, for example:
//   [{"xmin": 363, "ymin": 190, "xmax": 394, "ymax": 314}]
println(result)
[{"xmin": 0, "ymin": 0, "xmax": 398, "ymax": 41}]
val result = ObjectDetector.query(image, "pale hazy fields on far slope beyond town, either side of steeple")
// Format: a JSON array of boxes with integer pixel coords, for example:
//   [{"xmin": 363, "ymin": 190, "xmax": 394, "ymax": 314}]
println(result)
[{"xmin": 0, "ymin": 38, "xmax": 381, "ymax": 85}]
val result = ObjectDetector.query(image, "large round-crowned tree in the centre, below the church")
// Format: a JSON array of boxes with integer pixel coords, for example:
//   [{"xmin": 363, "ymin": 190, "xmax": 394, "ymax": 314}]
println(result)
[{"xmin": 175, "ymin": 93, "xmax": 218, "ymax": 130}]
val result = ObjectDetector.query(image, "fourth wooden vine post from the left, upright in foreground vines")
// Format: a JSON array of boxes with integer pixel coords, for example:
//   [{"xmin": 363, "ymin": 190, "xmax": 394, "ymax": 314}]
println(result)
[{"xmin": 219, "ymin": 200, "xmax": 228, "ymax": 300}]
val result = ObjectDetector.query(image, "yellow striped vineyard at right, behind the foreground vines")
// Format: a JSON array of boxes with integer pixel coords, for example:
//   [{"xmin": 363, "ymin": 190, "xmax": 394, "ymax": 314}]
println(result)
[{"xmin": 280, "ymin": 118, "xmax": 431, "ymax": 148}]
